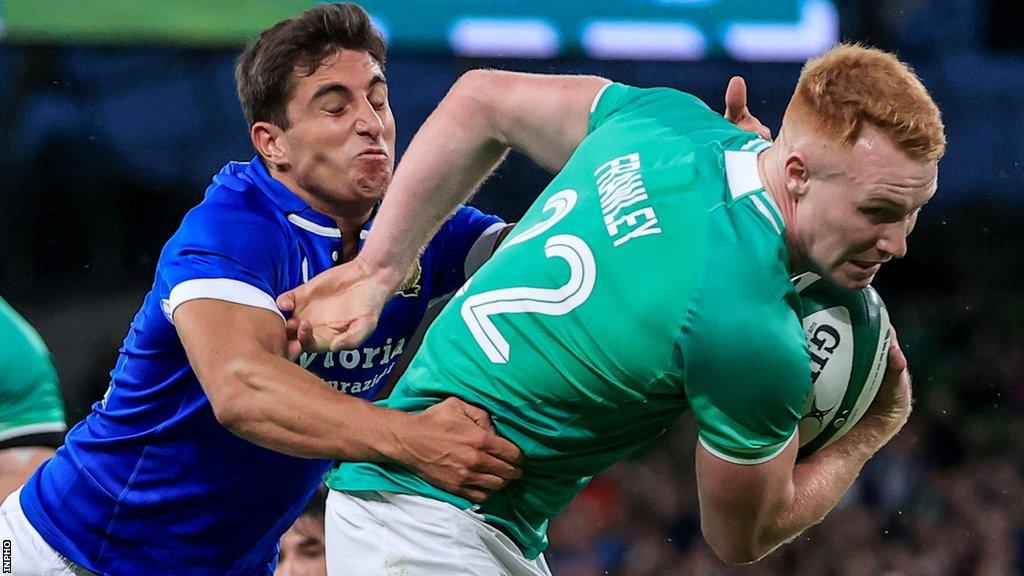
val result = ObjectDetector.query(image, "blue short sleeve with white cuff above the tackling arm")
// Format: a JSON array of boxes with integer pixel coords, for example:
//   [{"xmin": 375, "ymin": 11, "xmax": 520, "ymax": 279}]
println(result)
[{"xmin": 155, "ymin": 199, "xmax": 290, "ymax": 320}]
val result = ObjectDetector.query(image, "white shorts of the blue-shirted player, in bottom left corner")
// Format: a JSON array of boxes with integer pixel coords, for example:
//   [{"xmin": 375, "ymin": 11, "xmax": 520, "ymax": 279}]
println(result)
[{"xmin": 0, "ymin": 488, "xmax": 94, "ymax": 576}]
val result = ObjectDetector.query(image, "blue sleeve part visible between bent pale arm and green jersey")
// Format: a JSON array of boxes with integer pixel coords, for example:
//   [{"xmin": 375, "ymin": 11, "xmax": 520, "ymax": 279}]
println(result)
[{"xmin": 430, "ymin": 206, "xmax": 505, "ymax": 297}]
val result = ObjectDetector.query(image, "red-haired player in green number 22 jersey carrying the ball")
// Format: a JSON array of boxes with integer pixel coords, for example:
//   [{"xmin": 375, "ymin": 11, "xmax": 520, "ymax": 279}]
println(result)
[{"xmin": 279, "ymin": 45, "xmax": 945, "ymax": 575}]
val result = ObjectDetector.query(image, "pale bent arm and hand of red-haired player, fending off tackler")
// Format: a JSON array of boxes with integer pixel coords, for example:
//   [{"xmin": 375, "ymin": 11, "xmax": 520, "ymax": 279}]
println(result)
[{"xmin": 278, "ymin": 70, "xmax": 609, "ymax": 354}]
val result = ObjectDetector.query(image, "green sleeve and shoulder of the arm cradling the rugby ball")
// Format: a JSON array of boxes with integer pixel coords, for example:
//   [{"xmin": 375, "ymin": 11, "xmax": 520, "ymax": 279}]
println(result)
[{"xmin": 678, "ymin": 206, "xmax": 811, "ymax": 464}]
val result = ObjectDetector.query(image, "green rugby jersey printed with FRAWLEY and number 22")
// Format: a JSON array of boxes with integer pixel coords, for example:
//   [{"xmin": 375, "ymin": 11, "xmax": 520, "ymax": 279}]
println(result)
[{"xmin": 328, "ymin": 84, "xmax": 811, "ymax": 558}]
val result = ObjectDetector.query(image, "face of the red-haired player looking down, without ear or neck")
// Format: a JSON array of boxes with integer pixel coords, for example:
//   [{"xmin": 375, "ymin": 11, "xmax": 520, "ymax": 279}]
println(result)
[{"xmin": 796, "ymin": 126, "xmax": 937, "ymax": 289}]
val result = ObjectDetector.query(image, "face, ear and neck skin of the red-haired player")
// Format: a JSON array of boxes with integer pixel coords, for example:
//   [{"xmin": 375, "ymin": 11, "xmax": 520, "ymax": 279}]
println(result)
[{"xmin": 759, "ymin": 121, "xmax": 938, "ymax": 289}]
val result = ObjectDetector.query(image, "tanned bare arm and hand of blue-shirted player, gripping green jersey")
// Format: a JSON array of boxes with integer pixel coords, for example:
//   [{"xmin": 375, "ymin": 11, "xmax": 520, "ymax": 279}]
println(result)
[{"xmin": 174, "ymin": 299, "xmax": 521, "ymax": 501}]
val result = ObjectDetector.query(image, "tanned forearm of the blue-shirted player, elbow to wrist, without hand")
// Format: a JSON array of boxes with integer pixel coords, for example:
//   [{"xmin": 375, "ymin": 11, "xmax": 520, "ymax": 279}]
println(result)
[{"xmin": 214, "ymin": 354, "xmax": 406, "ymax": 461}]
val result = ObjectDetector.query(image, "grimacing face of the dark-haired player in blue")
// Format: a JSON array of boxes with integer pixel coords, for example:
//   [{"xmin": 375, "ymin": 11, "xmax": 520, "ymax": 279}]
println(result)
[{"xmin": 283, "ymin": 50, "xmax": 395, "ymax": 211}]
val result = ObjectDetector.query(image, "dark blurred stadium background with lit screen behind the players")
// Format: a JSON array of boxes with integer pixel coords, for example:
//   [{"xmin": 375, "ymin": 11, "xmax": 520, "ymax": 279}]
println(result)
[{"xmin": 0, "ymin": 0, "xmax": 1024, "ymax": 576}]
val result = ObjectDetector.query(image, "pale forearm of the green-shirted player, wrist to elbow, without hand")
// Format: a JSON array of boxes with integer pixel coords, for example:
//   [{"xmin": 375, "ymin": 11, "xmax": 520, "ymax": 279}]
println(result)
[{"xmin": 360, "ymin": 73, "xmax": 509, "ymax": 285}]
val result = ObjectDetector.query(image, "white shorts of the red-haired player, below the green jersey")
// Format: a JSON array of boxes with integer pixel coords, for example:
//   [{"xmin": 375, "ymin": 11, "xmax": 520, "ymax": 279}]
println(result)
[{"xmin": 325, "ymin": 490, "xmax": 551, "ymax": 576}]
